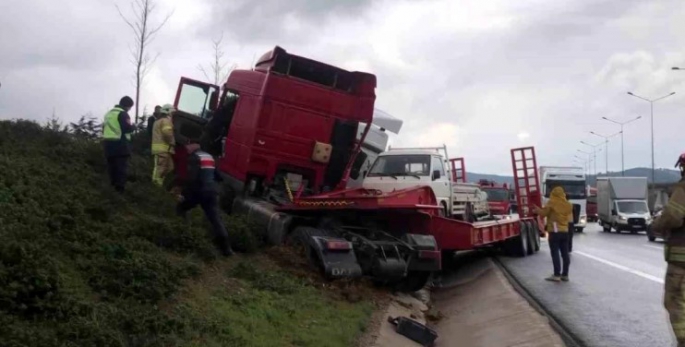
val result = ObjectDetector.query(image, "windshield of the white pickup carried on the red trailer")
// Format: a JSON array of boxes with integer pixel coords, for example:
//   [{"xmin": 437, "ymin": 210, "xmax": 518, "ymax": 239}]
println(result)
[{"xmin": 367, "ymin": 155, "xmax": 431, "ymax": 177}]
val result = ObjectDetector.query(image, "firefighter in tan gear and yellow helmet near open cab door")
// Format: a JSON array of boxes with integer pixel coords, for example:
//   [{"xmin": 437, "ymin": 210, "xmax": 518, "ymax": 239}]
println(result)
[{"xmin": 151, "ymin": 104, "xmax": 176, "ymax": 187}]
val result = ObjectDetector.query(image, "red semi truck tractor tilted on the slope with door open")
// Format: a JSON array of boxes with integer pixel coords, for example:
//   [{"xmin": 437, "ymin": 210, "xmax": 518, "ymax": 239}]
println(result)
[{"xmin": 173, "ymin": 46, "xmax": 441, "ymax": 291}]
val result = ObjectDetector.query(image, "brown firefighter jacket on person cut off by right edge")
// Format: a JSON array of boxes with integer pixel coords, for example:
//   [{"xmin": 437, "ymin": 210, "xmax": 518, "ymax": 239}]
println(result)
[{"xmin": 652, "ymin": 179, "xmax": 685, "ymax": 264}]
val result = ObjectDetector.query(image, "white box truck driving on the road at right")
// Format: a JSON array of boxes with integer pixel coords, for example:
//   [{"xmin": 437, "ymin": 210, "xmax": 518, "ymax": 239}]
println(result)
[{"xmin": 597, "ymin": 177, "xmax": 652, "ymax": 233}]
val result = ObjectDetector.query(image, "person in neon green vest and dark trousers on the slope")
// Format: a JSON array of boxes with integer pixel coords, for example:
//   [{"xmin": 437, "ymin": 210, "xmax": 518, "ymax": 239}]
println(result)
[{"xmin": 102, "ymin": 96, "xmax": 134, "ymax": 193}]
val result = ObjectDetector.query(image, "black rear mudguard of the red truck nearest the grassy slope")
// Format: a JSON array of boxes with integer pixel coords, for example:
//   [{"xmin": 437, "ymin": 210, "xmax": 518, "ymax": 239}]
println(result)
[{"xmin": 310, "ymin": 236, "xmax": 362, "ymax": 279}]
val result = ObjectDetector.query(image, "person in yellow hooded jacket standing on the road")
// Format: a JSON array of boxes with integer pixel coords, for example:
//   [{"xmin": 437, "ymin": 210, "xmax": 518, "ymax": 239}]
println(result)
[{"xmin": 534, "ymin": 187, "xmax": 573, "ymax": 282}]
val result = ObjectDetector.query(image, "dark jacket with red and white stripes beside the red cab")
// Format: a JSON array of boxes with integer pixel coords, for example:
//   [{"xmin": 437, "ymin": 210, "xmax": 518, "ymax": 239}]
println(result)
[{"xmin": 182, "ymin": 149, "xmax": 223, "ymax": 197}]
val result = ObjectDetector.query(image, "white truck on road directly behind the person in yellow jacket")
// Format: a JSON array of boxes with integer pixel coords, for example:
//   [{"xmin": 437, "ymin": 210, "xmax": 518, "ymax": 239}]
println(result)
[{"xmin": 540, "ymin": 166, "xmax": 587, "ymax": 232}]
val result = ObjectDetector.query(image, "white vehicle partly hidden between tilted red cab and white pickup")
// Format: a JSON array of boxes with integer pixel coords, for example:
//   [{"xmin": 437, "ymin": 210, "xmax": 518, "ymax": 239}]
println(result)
[{"xmin": 347, "ymin": 108, "xmax": 403, "ymax": 188}]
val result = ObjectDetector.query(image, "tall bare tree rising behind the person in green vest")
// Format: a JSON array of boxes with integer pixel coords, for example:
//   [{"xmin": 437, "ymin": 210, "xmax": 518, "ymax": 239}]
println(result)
[{"xmin": 115, "ymin": 0, "xmax": 174, "ymax": 123}]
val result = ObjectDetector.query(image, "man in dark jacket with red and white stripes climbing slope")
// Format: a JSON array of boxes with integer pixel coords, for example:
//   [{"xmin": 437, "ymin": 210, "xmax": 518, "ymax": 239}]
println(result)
[{"xmin": 176, "ymin": 142, "xmax": 233, "ymax": 256}]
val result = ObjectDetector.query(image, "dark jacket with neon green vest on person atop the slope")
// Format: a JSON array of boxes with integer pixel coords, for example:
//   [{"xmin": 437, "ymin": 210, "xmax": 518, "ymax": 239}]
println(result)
[{"xmin": 102, "ymin": 105, "xmax": 133, "ymax": 157}]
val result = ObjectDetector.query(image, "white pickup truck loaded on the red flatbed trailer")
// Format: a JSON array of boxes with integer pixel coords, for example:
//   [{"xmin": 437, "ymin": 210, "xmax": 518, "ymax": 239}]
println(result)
[{"xmin": 362, "ymin": 147, "xmax": 489, "ymax": 220}]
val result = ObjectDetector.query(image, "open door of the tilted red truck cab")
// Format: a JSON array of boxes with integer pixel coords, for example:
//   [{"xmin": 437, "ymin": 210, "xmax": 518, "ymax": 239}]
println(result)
[{"xmin": 173, "ymin": 77, "xmax": 220, "ymax": 144}]
